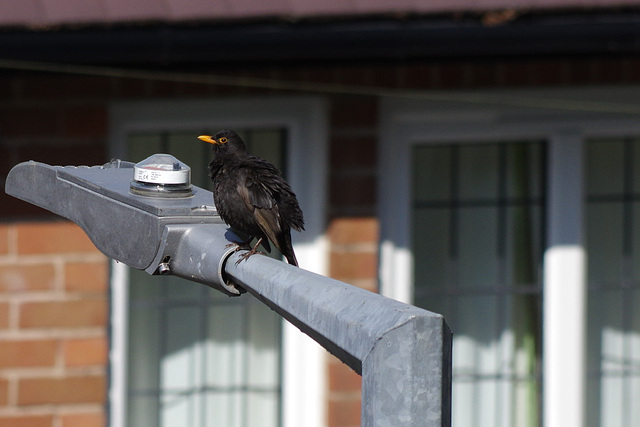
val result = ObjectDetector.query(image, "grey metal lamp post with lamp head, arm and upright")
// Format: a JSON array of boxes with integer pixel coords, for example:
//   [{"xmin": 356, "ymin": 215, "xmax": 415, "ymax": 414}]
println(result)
[{"xmin": 5, "ymin": 158, "xmax": 452, "ymax": 427}]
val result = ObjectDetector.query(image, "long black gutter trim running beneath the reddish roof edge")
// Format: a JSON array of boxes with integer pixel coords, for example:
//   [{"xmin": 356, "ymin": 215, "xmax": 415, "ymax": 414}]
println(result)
[{"xmin": 0, "ymin": 11, "xmax": 640, "ymax": 67}]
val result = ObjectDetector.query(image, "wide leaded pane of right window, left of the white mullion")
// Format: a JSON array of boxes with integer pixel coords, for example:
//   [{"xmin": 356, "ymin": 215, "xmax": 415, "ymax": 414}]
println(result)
[{"xmin": 412, "ymin": 142, "xmax": 544, "ymax": 427}]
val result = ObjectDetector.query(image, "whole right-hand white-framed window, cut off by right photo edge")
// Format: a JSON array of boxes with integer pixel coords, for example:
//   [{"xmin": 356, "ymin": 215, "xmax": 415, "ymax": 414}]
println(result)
[{"xmin": 378, "ymin": 87, "xmax": 640, "ymax": 427}]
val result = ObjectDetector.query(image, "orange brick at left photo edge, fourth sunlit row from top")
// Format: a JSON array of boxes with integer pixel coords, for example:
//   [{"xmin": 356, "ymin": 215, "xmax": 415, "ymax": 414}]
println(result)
[{"xmin": 0, "ymin": 340, "xmax": 57, "ymax": 368}]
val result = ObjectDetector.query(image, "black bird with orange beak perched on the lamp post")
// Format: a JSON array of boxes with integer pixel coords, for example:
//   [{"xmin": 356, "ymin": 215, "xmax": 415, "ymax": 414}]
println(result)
[{"xmin": 198, "ymin": 130, "xmax": 304, "ymax": 266}]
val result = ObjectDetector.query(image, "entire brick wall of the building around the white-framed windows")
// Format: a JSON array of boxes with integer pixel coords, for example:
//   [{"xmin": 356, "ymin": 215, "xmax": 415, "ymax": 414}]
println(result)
[{"xmin": 0, "ymin": 59, "xmax": 640, "ymax": 427}]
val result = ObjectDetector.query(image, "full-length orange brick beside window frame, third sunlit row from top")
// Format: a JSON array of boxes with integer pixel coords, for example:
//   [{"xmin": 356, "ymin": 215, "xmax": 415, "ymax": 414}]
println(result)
[{"xmin": 19, "ymin": 298, "xmax": 107, "ymax": 328}]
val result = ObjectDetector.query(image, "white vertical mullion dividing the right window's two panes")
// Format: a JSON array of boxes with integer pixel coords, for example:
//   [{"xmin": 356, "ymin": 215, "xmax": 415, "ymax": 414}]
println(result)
[{"xmin": 543, "ymin": 134, "xmax": 586, "ymax": 427}]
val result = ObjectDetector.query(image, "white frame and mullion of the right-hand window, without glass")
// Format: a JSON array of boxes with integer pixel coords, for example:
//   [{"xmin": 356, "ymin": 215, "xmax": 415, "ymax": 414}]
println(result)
[{"xmin": 378, "ymin": 86, "xmax": 640, "ymax": 427}]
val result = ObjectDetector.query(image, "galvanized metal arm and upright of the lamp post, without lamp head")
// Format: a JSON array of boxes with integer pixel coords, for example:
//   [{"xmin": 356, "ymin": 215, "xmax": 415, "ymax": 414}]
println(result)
[{"xmin": 225, "ymin": 253, "xmax": 452, "ymax": 427}]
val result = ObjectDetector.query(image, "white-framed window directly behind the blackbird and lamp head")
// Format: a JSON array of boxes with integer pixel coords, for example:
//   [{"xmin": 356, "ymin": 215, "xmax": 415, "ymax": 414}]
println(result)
[{"xmin": 110, "ymin": 98, "xmax": 326, "ymax": 427}]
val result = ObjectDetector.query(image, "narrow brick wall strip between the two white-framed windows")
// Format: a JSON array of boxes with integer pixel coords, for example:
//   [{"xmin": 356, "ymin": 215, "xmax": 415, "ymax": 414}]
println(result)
[{"xmin": 327, "ymin": 91, "xmax": 380, "ymax": 427}]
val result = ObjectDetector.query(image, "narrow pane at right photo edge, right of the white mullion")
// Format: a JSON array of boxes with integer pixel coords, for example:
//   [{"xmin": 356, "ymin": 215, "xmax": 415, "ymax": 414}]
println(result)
[{"xmin": 586, "ymin": 138, "xmax": 640, "ymax": 427}]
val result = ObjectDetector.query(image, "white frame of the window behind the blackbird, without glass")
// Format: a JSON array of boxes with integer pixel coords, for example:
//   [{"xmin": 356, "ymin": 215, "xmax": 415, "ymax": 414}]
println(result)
[{"xmin": 109, "ymin": 97, "xmax": 328, "ymax": 427}]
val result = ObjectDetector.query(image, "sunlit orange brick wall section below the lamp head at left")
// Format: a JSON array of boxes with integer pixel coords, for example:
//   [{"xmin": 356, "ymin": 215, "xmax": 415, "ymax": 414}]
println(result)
[{"xmin": 0, "ymin": 221, "xmax": 108, "ymax": 427}]
